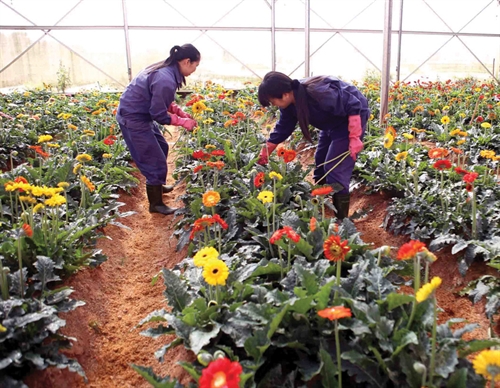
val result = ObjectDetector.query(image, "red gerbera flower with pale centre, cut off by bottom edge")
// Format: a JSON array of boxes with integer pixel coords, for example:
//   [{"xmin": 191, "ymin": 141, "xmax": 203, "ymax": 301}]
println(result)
[{"xmin": 198, "ymin": 358, "xmax": 243, "ymax": 388}]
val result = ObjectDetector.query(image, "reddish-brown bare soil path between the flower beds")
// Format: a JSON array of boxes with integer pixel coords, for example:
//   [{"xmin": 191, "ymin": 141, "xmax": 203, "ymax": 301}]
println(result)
[{"xmin": 25, "ymin": 135, "xmax": 490, "ymax": 388}]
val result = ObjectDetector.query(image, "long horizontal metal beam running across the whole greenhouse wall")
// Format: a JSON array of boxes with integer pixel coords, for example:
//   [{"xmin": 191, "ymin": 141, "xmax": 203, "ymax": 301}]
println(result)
[{"xmin": 0, "ymin": 24, "xmax": 500, "ymax": 38}]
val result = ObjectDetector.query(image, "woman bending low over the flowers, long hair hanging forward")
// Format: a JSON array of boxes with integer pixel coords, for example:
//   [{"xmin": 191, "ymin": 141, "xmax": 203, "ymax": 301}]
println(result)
[{"xmin": 258, "ymin": 71, "xmax": 370, "ymax": 219}]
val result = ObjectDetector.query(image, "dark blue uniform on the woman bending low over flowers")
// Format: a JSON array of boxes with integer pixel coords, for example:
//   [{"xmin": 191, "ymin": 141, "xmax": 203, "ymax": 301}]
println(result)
[{"xmin": 268, "ymin": 77, "xmax": 370, "ymax": 194}]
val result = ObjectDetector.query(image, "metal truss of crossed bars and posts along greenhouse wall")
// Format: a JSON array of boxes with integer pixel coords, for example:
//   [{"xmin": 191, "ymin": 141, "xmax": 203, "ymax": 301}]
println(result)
[{"xmin": 0, "ymin": 0, "xmax": 500, "ymax": 121}]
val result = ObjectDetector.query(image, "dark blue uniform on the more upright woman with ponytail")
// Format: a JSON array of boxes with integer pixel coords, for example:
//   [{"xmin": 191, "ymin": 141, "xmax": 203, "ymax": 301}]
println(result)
[{"xmin": 116, "ymin": 64, "xmax": 182, "ymax": 185}]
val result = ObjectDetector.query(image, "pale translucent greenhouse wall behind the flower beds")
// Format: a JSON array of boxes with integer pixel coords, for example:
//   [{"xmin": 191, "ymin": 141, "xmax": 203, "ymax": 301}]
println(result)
[{"xmin": 0, "ymin": 0, "xmax": 500, "ymax": 90}]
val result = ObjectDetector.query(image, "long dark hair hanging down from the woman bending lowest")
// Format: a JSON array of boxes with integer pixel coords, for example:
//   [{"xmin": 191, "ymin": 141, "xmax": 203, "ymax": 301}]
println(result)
[{"xmin": 259, "ymin": 71, "xmax": 312, "ymax": 142}]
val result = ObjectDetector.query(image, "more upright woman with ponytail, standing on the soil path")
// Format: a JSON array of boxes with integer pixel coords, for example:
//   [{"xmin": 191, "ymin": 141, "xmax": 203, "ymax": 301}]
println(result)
[{"xmin": 116, "ymin": 44, "xmax": 201, "ymax": 215}]
